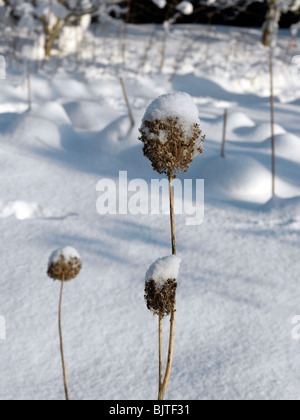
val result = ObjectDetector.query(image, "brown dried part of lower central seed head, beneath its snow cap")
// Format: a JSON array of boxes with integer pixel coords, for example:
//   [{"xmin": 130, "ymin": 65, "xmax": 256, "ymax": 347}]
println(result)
[{"xmin": 145, "ymin": 279, "xmax": 177, "ymax": 317}]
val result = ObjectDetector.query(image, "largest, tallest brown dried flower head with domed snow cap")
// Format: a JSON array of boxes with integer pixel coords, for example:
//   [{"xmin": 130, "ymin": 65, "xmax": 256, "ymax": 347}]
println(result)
[{"xmin": 139, "ymin": 93, "xmax": 205, "ymax": 178}]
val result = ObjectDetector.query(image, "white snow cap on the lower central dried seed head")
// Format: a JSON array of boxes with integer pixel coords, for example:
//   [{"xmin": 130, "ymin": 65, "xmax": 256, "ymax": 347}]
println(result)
[{"xmin": 146, "ymin": 255, "xmax": 182, "ymax": 289}]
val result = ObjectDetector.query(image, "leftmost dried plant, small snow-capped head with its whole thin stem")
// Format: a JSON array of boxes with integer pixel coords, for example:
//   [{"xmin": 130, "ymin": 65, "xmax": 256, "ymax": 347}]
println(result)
[{"xmin": 47, "ymin": 247, "xmax": 82, "ymax": 401}]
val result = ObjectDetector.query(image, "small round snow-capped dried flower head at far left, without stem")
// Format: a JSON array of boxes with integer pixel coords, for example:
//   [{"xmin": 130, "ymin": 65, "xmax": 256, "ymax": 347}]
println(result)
[{"xmin": 47, "ymin": 247, "xmax": 82, "ymax": 281}]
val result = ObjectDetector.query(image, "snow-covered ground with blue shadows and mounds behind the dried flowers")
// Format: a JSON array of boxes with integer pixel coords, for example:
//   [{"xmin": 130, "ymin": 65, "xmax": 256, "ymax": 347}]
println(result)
[{"xmin": 0, "ymin": 26, "xmax": 300, "ymax": 400}]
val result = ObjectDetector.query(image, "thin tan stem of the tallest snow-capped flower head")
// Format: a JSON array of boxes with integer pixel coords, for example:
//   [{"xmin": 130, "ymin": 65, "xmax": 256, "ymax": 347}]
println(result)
[{"xmin": 158, "ymin": 177, "xmax": 176, "ymax": 401}]
